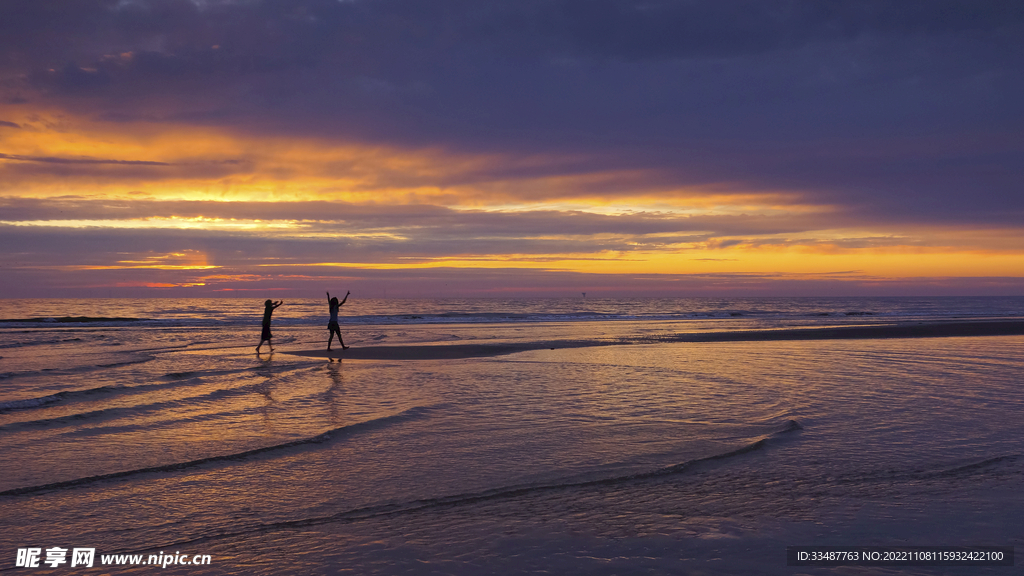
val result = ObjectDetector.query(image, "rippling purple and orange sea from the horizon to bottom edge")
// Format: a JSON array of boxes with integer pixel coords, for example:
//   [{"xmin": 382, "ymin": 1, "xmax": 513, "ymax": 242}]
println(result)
[{"xmin": 0, "ymin": 295, "xmax": 1024, "ymax": 575}]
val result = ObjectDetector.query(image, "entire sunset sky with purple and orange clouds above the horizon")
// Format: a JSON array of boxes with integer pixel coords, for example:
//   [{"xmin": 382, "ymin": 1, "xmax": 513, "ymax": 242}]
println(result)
[{"xmin": 0, "ymin": 0, "xmax": 1024, "ymax": 298}]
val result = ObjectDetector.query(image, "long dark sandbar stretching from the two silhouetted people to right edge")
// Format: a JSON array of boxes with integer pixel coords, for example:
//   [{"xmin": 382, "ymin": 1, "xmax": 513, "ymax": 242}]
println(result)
[{"xmin": 279, "ymin": 320, "xmax": 1024, "ymax": 360}]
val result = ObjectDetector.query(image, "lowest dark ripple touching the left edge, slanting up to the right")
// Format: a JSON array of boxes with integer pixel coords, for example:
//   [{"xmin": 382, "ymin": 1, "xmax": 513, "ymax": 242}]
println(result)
[{"xmin": 0, "ymin": 406, "xmax": 433, "ymax": 496}]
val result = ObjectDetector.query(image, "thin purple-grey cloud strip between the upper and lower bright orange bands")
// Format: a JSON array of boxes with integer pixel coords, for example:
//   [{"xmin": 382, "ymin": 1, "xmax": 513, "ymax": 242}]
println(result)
[{"xmin": 0, "ymin": 197, "xmax": 847, "ymax": 237}]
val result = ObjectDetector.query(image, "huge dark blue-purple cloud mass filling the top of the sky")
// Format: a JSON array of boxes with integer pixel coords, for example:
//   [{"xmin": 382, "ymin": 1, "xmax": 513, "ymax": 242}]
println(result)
[{"xmin": 0, "ymin": 0, "xmax": 1024, "ymax": 223}]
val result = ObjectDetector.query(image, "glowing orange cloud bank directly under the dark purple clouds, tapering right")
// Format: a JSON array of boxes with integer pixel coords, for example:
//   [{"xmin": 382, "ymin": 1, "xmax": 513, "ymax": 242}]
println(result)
[{"xmin": 0, "ymin": 109, "xmax": 818, "ymax": 213}]
